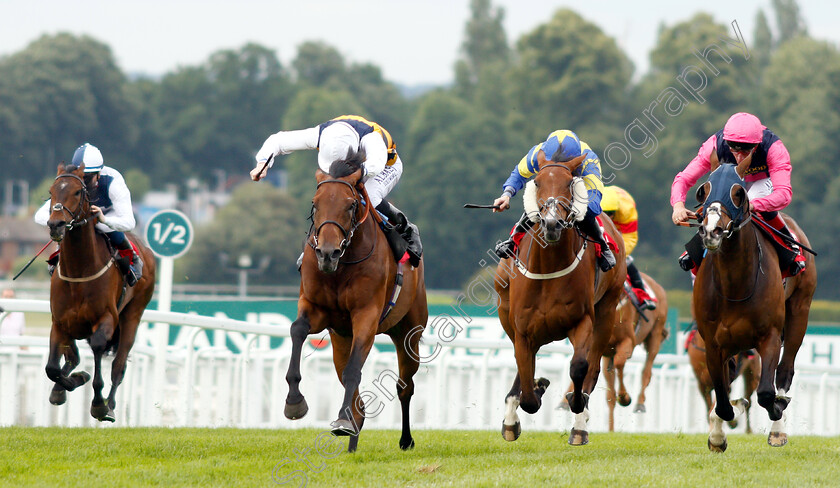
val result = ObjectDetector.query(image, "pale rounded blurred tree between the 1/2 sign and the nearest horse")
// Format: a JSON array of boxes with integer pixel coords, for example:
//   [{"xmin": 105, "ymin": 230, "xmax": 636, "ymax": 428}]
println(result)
[{"xmin": 179, "ymin": 182, "xmax": 306, "ymax": 284}]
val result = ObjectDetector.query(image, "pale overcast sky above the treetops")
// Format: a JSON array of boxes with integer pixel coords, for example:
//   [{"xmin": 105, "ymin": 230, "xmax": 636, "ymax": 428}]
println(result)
[{"xmin": 0, "ymin": 0, "xmax": 840, "ymax": 86}]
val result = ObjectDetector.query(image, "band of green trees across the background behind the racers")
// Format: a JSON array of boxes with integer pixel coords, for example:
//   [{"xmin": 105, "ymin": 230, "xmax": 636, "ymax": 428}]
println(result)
[{"xmin": 0, "ymin": 0, "xmax": 840, "ymax": 298}]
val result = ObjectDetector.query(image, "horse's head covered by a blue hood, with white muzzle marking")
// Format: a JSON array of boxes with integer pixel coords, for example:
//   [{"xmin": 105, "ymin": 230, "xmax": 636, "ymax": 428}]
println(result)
[{"xmin": 696, "ymin": 152, "xmax": 752, "ymax": 251}]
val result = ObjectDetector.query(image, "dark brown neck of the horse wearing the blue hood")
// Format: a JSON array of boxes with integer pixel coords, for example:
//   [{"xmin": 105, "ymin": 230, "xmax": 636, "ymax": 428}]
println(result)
[{"xmin": 712, "ymin": 225, "xmax": 761, "ymax": 296}]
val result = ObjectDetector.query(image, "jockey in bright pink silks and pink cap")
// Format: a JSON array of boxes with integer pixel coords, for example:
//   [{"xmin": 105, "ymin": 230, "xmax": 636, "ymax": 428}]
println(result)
[{"xmin": 671, "ymin": 112, "xmax": 805, "ymax": 276}]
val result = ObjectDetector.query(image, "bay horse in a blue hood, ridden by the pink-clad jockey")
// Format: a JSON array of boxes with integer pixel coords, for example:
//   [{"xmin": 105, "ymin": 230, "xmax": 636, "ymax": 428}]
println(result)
[{"xmin": 693, "ymin": 154, "xmax": 817, "ymax": 452}]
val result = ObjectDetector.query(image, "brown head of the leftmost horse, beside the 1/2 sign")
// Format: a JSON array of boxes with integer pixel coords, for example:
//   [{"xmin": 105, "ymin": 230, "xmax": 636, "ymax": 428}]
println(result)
[{"xmin": 47, "ymin": 163, "xmax": 90, "ymax": 242}]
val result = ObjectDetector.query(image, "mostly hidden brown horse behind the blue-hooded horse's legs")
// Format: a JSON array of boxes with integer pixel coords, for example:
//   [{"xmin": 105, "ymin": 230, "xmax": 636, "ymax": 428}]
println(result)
[{"xmin": 686, "ymin": 331, "xmax": 761, "ymax": 434}]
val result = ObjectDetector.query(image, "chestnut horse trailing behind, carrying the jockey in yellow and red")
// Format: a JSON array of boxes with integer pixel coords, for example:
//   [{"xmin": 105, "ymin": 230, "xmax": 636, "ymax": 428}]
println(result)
[{"xmin": 560, "ymin": 273, "xmax": 668, "ymax": 432}]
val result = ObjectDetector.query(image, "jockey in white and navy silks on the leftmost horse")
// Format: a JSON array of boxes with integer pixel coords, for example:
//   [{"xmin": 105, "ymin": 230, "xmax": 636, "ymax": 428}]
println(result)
[{"xmin": 34, "ymin": 143, "xmax": 143, "ymax": 286}]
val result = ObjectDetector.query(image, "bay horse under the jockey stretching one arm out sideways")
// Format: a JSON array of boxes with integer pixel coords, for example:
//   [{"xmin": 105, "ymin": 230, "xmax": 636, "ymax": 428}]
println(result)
[{"xmin": 284, "ymin": 151, "xmax": 429, "ymax": 452}]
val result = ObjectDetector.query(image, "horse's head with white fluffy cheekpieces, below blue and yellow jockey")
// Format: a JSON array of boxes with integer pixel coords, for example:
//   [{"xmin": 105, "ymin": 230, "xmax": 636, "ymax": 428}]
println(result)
[{"xmin": 526, "ymin": 151, "xmax": 587, "ymax": 242}]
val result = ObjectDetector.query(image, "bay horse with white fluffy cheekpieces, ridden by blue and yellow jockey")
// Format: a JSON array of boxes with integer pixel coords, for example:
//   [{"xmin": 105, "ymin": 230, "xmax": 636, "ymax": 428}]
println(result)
[{"xmin": 495, "ymin": 152, "xmax": 627, "ymax": 445}]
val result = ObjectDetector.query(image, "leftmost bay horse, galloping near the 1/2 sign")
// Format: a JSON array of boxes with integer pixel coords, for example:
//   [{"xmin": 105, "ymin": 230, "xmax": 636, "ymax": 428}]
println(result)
[{"xmin": 45, "ymin": 164, "xmax": 155, "ymax": 422}]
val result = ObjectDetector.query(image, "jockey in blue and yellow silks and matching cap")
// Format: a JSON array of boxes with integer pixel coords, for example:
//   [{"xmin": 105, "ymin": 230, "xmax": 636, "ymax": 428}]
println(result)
[{"xmin": 493, "ymin": 130, "xmax": 615, "ymax": 271}]
